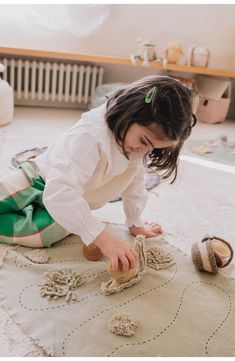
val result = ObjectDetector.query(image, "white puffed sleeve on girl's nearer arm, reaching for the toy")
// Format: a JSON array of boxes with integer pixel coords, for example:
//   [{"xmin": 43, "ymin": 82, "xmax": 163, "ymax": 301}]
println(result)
[{"xmin": 43, "ymin": 133, "xmax": 105, "ymax": 245}]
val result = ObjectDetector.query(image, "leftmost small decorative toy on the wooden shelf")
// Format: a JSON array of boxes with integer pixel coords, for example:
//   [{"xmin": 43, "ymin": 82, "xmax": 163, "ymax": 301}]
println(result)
[{"xmin": 130, "ymin": 38, "xmax": 157, "ymax": 66}]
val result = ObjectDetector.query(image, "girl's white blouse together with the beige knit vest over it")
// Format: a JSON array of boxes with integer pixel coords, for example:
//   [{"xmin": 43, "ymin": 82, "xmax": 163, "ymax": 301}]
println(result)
[{"xmin": 35, "ymin": 104, "xmax": 147, "ymax": 244}]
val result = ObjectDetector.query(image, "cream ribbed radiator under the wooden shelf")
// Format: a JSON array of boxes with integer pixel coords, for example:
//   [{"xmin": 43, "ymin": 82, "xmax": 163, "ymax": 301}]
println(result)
[{"xmin": 0, "ymin": 57, "xmax": 103, "ymax": 108}]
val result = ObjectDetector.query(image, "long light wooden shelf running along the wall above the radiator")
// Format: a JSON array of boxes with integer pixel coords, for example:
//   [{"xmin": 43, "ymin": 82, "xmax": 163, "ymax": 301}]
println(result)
[{"xmin": 0, "ymin": 47, "xmax": 235, "ymax": 78}]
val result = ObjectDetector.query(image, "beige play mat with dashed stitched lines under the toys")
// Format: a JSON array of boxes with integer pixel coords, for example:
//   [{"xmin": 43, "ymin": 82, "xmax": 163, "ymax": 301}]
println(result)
[{"xmin": 0, "ymin": 225, "xmax": 235, "ymax": 357}]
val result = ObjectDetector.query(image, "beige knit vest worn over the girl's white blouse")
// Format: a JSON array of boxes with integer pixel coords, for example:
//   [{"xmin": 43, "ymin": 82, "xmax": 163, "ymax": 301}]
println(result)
[{"xmin": 83, "ymin": 149, "xmax": 139, "ymax": 209}]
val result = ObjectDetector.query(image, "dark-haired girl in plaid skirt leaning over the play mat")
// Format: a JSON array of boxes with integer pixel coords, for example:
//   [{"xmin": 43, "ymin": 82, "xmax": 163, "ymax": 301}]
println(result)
[{"xmin": 0, "ymin": 75, "xmax": 195, "ymax": 271}]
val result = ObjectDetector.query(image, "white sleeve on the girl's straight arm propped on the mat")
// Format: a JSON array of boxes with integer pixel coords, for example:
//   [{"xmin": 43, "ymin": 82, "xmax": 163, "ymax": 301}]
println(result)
[{"xmin": 122, "ymin": 167, "xmax": 148, "ymax": 227}]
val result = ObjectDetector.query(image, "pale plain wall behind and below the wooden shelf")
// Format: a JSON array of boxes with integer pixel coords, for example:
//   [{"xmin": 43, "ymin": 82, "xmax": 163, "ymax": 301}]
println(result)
[{"xmin": 0, "ymin": 4, "xmax": 235, "ymax": 116}]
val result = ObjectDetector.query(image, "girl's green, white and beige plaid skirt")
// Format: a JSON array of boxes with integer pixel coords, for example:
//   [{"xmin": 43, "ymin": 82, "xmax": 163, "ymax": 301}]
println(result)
[{"xmin": 0, "ymin": 161, "xmax": 69, "ymax": 247}]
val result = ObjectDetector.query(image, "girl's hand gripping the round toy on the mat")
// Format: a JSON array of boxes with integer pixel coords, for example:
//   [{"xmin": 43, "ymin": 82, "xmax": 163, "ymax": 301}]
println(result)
[{"xmin": 93, "ymin": 231, "xmax": 138, "ymax": 272}]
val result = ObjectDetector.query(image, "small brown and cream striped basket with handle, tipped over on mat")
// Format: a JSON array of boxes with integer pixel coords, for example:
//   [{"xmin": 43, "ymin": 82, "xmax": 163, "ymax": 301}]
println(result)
[{"xmin": 192, "ymin": 236, "xmax": 233, "ymax": 273}]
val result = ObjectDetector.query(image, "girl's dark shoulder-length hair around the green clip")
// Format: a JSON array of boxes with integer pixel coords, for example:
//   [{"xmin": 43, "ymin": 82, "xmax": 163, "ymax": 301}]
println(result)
[{"xmin": 105, "ymin": 75, "xmax": 196, "ymax": 183}]
